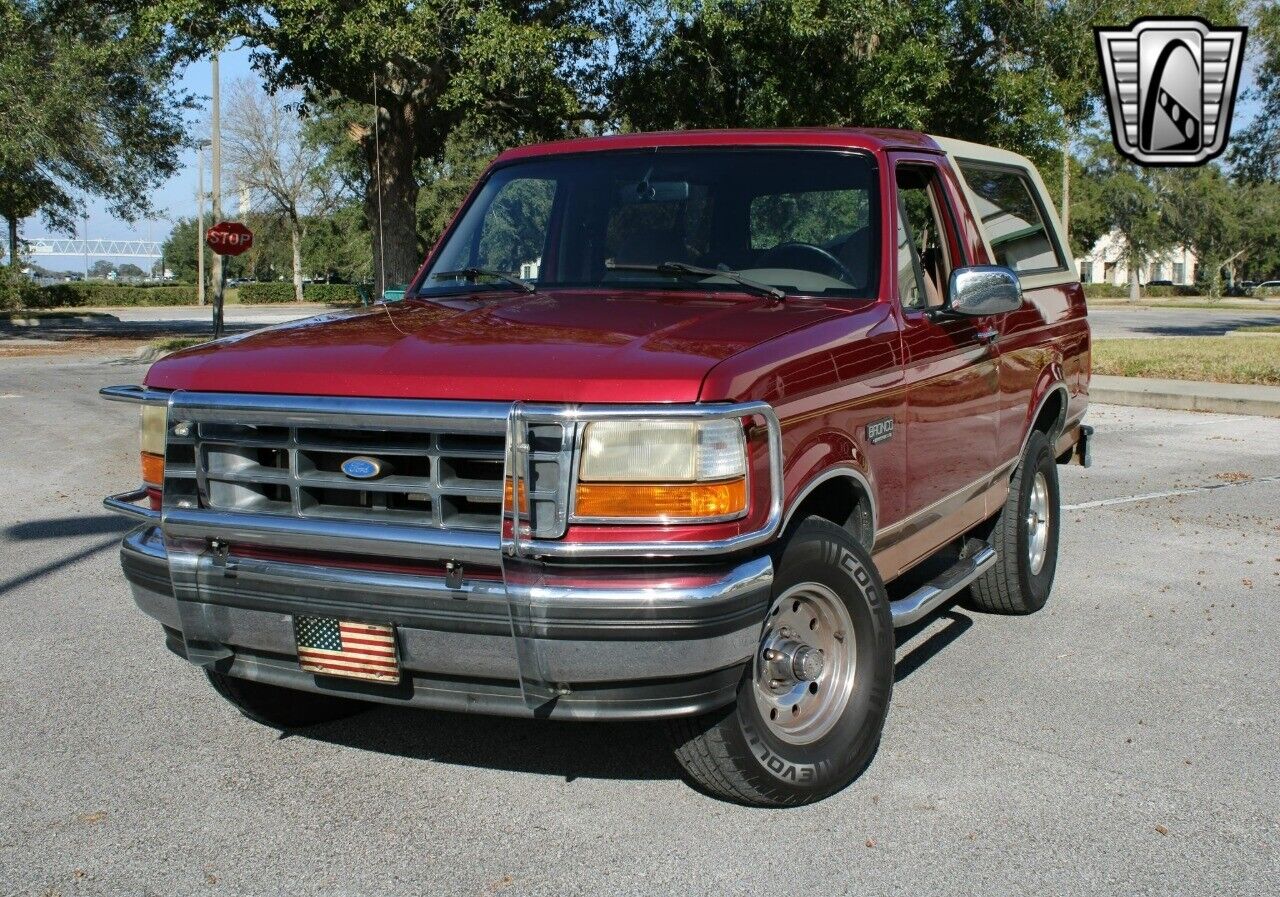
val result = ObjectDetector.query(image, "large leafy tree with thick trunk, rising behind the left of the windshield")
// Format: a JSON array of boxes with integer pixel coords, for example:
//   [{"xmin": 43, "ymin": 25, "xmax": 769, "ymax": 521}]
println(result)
[{"xmin": 127, "ymin": 0, "xmax": 625, "ymax": 290}]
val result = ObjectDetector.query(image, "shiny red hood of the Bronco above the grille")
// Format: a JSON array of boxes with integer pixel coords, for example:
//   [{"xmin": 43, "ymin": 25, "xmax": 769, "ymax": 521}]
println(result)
[{"xmin": 146, "ymin": 290, "xmax": 841, "ymax": 402}]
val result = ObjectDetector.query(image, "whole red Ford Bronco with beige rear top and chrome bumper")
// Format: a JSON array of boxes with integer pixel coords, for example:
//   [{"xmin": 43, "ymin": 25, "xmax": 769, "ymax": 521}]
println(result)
[{"xmin": 102, "ymin": 129, "xmax": 1091, "ymax": 805}]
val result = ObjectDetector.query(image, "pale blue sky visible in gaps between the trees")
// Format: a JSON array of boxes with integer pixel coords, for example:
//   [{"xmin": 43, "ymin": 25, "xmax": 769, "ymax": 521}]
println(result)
[{"xmin": 19, "ymin": 32, "xmax": 1257, "ymax": 271}]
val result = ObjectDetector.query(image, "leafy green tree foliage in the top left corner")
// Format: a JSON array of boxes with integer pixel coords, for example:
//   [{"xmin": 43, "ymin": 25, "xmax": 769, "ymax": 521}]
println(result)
[{"xmin": 0, "ymin": 0, "xmax": 191, "ymax": 262}]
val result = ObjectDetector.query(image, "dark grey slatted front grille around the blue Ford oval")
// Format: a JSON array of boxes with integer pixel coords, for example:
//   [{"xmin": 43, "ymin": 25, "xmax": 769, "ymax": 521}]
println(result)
[{"xmin": 165, "ymin": 407, "xmax": 573, "ymax": 537}]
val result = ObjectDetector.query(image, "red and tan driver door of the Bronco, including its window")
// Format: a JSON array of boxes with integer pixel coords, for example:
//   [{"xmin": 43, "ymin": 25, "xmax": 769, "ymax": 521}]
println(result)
[{"xmin": 895, "ymin": 154, "xmax": 1000, "ymax": 516}]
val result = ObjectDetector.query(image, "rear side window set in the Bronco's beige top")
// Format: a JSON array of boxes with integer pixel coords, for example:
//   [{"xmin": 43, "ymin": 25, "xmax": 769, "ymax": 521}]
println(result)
[{"xmin": 960, "ymin": 163, "xmax": 1066, "ymax": 274}]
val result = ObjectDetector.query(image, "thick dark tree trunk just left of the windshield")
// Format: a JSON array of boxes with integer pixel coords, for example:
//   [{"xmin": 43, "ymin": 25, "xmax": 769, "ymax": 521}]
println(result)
[{"xmin": 365, "ymin": 104, "xmax": 422, "ymax": 298}]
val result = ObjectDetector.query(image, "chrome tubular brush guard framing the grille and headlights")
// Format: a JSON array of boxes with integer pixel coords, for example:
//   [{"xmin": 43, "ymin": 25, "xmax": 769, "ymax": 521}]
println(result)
[{"xmin": 101, "ymin": 386, "xmax": 783, "ymax": 566}]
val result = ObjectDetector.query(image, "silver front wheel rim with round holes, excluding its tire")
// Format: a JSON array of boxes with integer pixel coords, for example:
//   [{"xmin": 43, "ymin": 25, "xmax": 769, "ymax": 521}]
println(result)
[{"xmin": 753, "ymin": 582, "xmax": 858, "ymax": 745}]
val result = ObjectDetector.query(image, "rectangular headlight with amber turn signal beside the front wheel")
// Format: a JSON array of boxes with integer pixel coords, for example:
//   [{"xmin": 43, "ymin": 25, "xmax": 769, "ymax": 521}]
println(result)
[{"xmin": 573, "ymin": 418, "xmax": 746, "ymax": 522}]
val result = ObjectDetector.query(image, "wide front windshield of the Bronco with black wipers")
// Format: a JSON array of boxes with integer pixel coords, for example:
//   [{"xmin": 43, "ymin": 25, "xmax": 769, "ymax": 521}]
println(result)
[{"xmin": 417, "ymin": 148, "xmax": 878, "ymax": 298}]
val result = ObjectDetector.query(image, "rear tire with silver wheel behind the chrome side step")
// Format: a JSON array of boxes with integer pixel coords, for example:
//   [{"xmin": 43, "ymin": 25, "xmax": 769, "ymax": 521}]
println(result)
[{"xmin": 969, "ymin": 430, "xmax": 1061, "ymax": 614}]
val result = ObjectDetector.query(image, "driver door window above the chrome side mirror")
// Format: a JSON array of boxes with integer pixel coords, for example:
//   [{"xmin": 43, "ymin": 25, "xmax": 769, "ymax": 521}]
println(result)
[{"xmin": 896, "ymin": 165, "xmax": 952, "ymax": 308}]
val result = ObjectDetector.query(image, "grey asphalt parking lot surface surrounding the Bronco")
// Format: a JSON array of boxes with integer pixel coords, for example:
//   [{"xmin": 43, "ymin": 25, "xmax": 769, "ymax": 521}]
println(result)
[{"xmin": 0, "ymin": 350, "xmax": 1280, "ymax": 897}]
